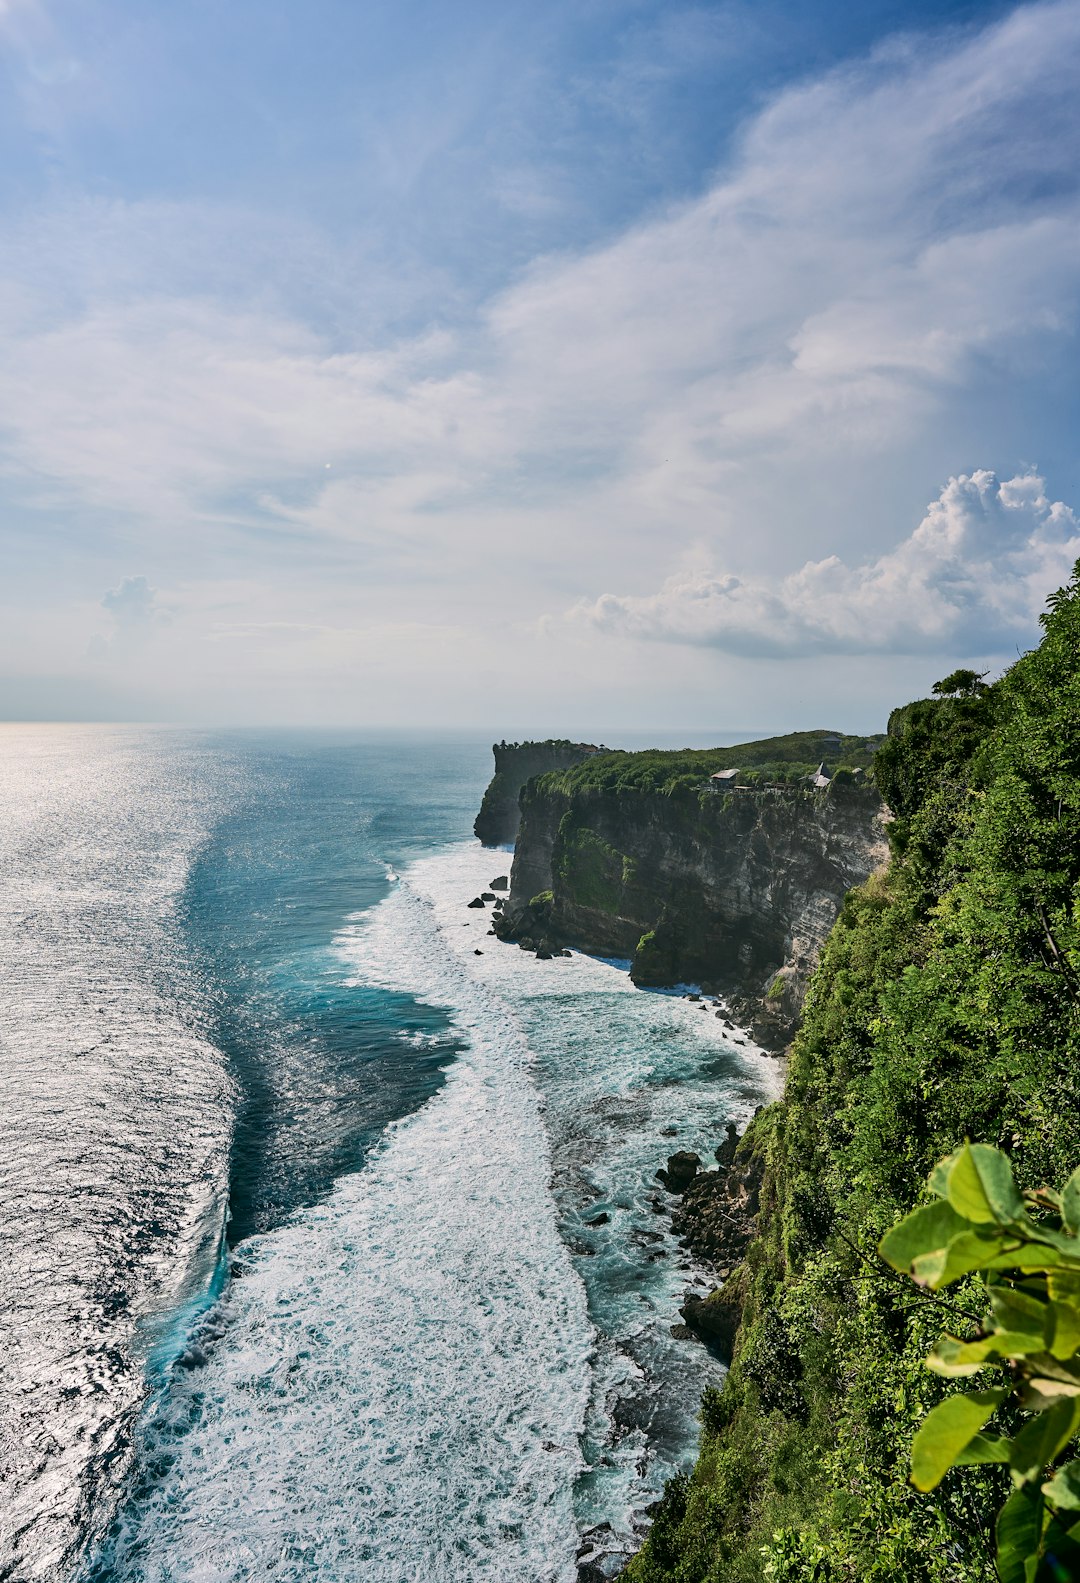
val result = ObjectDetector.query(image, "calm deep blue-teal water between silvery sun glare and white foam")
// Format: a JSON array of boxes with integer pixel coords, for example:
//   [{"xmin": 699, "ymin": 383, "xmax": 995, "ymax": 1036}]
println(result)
[{"xmin": 181, "ymin": 733, "xmax": 491, "ymax": 1244}]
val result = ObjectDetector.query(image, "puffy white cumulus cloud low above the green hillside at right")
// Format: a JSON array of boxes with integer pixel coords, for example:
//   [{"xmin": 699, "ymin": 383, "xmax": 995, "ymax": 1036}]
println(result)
[{"xmin": 570, "ymin": 472, "xmax": 1080, "ymax": 657}]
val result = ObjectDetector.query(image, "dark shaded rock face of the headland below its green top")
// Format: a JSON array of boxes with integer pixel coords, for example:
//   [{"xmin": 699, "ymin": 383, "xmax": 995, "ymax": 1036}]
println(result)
[{"xmin": 502, "ymin": 777, "xmax": 887, "ymax": 1046}]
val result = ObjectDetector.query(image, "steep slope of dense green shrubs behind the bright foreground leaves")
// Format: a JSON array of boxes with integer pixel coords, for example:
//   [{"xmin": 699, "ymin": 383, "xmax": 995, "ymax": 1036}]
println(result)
[{"xmin": 623, "ymin": 563, "xmax": 1080, "ymax": 1583}]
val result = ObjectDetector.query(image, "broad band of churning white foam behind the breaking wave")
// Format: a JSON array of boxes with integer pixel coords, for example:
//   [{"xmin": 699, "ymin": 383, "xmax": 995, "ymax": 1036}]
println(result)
[{"xmin": 105, "ymin": 848, "xmax": 595, "ymax": 1583}]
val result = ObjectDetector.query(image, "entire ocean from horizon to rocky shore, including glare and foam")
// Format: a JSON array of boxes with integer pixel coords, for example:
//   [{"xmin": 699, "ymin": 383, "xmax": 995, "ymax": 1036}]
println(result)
[{"xmin": 0, "ymin": 728, "xmax": 776, "ymax": 1583}]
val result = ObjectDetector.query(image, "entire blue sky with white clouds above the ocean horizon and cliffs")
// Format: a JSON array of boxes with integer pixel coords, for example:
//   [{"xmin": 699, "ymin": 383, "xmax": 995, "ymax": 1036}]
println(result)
[{"xmin": 0, "ymin": 0, "xmax": 1080, "ymax": 742}]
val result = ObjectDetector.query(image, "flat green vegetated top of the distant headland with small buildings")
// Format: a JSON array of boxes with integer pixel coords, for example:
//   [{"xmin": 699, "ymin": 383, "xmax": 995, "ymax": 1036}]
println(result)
[{"xmin": 542, "ymin": 731, "xmax": 885, "ymax": 793}]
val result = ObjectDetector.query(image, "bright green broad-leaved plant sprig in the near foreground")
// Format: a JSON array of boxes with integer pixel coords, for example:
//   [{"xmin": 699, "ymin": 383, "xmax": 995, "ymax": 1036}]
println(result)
[{"xmin": 880, "ymin": 1143, "xmax": 1080, "ymax": 1583}]
